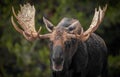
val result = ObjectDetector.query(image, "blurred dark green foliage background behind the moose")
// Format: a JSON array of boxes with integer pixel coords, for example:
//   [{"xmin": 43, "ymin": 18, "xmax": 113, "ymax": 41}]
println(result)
[{"xmin": 0, "ymin": 0, "xmax": 120, "ymax": 77}]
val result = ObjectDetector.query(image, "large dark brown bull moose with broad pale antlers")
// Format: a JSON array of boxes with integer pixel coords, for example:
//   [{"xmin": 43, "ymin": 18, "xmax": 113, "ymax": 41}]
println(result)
[{"xmin": 11, "ymin": 3, "xmax": 107, "ymax": 77}]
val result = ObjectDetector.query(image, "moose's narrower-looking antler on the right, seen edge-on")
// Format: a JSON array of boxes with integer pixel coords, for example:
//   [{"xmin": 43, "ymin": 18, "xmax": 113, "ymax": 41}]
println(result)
[{"xmin": 68, "ymin": 4, "xmax": 107, "ymax": 41}]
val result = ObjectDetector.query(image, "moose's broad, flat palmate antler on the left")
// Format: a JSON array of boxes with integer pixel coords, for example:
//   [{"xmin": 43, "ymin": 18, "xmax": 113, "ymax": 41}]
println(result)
[{"xmin": 11, "ymin": 3, "xmax": 49, "ymax": 41}]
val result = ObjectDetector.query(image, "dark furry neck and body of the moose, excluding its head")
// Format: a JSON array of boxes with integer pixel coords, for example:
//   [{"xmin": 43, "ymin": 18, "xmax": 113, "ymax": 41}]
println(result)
[{"xmin": 53, "ymin": 33, "xmax": 107, "ymax": 77}]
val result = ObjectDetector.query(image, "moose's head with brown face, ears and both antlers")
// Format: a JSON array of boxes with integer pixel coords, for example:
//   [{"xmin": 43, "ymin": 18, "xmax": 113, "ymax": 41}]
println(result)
[{"xmin": 11, "ymin": 3, "xmax": 107, "ymax": 71}]
